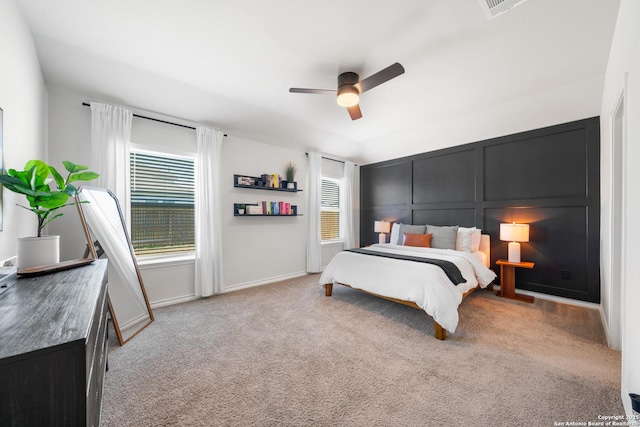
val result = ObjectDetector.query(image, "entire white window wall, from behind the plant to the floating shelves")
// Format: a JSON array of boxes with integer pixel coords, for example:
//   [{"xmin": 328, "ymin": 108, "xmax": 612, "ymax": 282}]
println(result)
[{"xmin": 49, "ymin": 87, "xmax": 308, "ymax": 306}]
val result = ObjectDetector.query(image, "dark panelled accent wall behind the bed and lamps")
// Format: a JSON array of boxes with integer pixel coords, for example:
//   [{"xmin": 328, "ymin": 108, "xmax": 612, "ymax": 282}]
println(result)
[{"xmin": 360, "ymin": 117, "xmax": 600, "ymax": 303}]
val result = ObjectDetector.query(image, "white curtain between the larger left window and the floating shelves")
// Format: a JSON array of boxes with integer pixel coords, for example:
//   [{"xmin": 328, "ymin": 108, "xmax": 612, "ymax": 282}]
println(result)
[{"xmin": 195, "ymin": 126, "xmax": 224, "ymax": 297}]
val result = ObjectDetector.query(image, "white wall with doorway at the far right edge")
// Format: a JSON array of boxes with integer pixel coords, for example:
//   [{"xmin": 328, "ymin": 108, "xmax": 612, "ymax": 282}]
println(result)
[{"xmin": 600, "ymin": 0, "xmax": 640, "ymax": 414}]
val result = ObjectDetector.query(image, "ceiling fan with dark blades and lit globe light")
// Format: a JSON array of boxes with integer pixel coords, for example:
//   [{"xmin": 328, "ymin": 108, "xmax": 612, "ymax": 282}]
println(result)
[{"xmin": 289, "ymin": 62, "xmax": 404, "ymax": 120}]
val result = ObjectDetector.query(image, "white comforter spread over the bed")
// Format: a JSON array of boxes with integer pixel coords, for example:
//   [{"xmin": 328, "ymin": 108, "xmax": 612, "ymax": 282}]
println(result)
[{"xmin": 320, "ymin": 244, "xmax": 496, "ymax": 333}]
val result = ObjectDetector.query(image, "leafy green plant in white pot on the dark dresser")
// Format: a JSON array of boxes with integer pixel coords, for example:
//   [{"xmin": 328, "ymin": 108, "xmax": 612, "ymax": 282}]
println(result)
[{"xmin": 0, "ymin": 160, "xmax": 99, "ymax": 268}]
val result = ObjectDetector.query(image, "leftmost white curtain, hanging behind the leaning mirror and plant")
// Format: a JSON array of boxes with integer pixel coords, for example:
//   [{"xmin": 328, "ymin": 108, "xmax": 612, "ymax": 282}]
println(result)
[{"xmin": 90, "ymin": 102, "xmax": 133, "ymax": 229}]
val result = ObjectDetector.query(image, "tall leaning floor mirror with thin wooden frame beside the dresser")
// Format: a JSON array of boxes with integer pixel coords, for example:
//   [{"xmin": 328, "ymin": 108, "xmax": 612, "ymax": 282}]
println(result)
[{"xmin": 76, "ymin": 187, "xmax": 153, "ymax": 345}]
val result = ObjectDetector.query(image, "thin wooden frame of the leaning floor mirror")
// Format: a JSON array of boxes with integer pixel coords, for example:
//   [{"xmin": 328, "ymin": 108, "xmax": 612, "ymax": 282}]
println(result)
[{"xmin": 75, "ymin": 186, "xmax": 155, "ymax": 345}]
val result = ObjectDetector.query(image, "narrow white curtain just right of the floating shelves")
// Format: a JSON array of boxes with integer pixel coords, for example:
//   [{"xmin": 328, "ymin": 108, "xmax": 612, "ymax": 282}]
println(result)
[{"xmin": 307, "ymin": 153, "xmax": 322, "ymax": 273}]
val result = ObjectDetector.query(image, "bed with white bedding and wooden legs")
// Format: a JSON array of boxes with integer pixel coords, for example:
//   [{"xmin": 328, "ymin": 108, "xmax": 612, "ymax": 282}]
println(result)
[{"xmin": 319, "ymin": 224, "xmax": 496, "ymax": 340}]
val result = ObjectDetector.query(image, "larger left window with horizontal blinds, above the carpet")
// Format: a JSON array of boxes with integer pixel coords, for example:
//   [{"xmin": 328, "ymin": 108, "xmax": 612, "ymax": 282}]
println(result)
[{"xmin": 130, "ymin": 150, "xmax": 195, "ymax": 256}]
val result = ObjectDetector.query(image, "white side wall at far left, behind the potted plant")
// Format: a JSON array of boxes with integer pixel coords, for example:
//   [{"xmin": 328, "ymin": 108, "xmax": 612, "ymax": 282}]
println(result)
[{"xmin": 0, "ymin": 0, "xmax": 47, "ymax": 255}]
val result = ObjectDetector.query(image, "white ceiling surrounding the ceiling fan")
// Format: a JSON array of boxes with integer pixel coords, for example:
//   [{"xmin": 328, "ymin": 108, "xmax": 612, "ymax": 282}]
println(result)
[{"xmin": 17, "ymin": 0, "xmax": 619, "ymax": 163}]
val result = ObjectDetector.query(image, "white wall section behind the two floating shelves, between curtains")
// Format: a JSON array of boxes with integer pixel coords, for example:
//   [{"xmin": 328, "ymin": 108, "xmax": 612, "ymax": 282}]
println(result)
[{"xmin": 221, "ymin": 139, "xmax": 308, "ymax": 288}]
